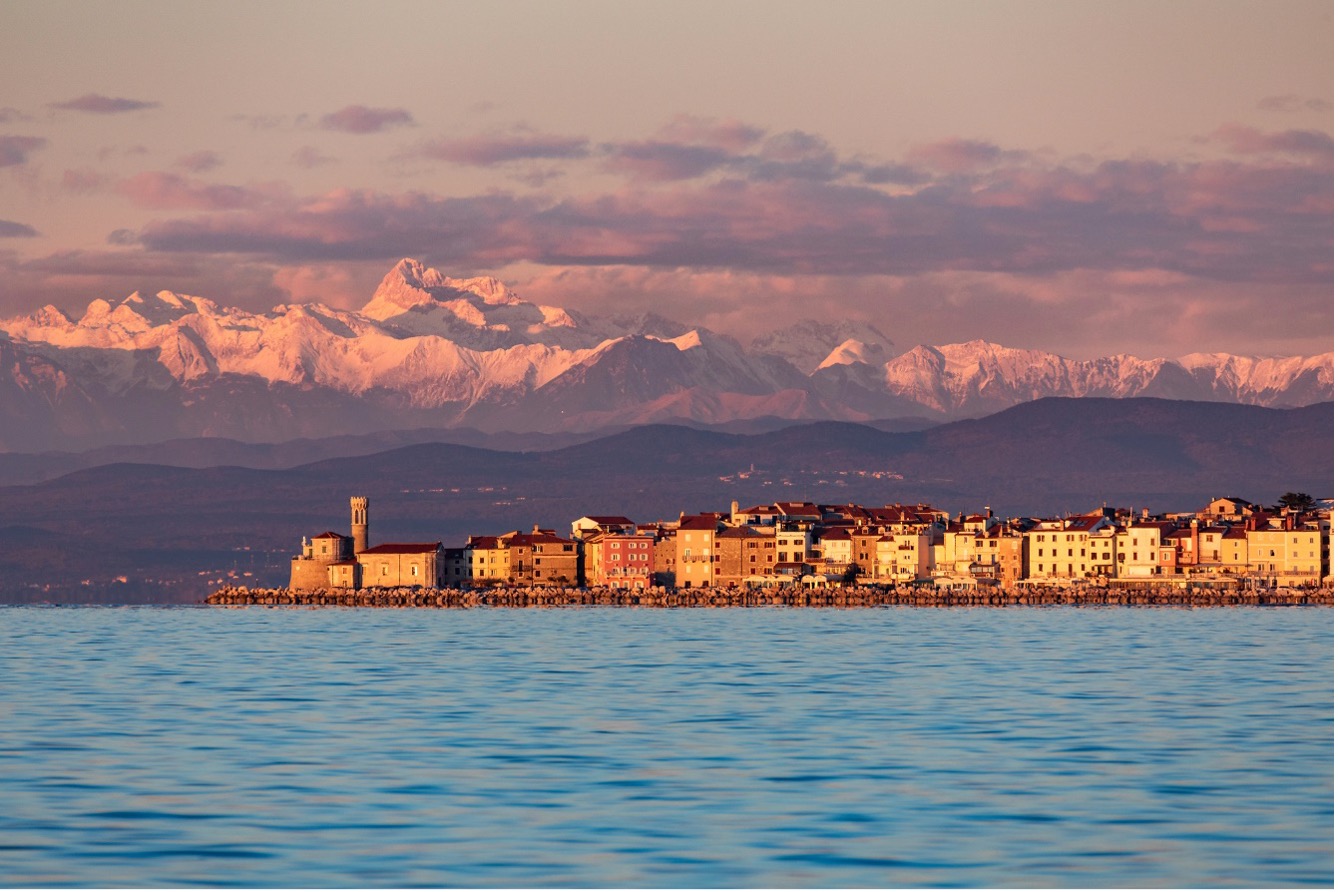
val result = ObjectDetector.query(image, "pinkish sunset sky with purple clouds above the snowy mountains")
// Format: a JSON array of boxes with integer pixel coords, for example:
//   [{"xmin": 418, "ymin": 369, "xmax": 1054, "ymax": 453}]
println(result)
[{"xmin": 0, "ymin": 0, "xmax": 1334, "ymax": 358}]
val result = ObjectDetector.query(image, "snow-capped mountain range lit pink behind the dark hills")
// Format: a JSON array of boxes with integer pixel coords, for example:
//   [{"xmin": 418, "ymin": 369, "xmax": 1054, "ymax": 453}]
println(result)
[{"xmin": 0, "ymin": 259, "xmax": 1333, "ymax": 452}]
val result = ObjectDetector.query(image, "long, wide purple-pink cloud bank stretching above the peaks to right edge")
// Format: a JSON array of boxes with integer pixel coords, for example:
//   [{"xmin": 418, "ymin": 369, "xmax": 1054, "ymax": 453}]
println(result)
[{"xmin": 123, "ymin": 143, "xmax": 1333, "ymax": 287}]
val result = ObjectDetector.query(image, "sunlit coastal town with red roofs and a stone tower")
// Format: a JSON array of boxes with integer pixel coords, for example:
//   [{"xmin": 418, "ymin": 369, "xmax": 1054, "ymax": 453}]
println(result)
[{"xmin": 216, "ymin": 493, "xmax": 1333, "ymax": 604}]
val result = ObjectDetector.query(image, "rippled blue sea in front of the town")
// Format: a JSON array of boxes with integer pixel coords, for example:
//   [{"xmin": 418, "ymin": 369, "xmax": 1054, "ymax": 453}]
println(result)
[{"xmin": 0, "ymin": 607, "xmax": 1334, "ymax": 887}]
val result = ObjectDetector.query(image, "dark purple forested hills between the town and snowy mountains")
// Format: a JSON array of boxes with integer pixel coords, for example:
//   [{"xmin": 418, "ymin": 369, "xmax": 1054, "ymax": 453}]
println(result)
[{"xmin": 0, "ymin": 399, "xmax": 1334, "ymax": 600}]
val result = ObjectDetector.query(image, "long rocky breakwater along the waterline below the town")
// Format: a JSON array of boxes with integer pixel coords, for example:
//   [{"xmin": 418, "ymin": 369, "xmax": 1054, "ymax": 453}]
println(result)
[{"xmin": 206, "ymin": 586, "xmax": 1334, "ymax": 608}]
